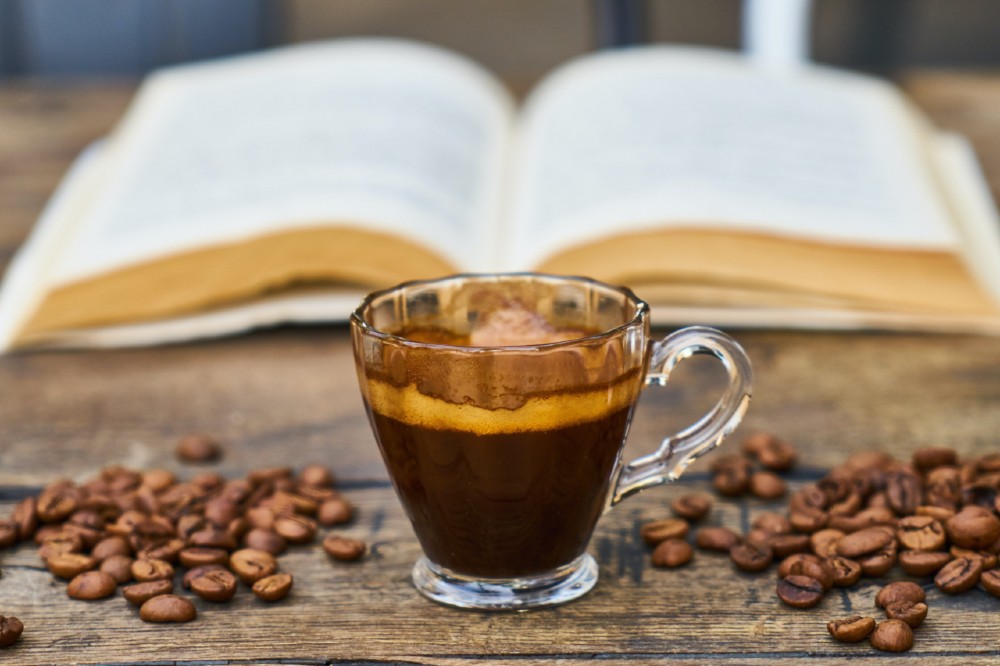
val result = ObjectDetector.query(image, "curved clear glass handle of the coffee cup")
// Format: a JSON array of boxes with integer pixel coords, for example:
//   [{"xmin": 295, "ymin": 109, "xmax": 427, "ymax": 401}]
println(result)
[{"xmin": 608, "ymin": 326, "xmax": 753, "ymax": 508}]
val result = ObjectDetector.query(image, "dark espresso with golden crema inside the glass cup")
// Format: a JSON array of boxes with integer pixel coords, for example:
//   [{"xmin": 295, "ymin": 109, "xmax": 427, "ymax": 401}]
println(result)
[{"xmin": 368, "ymin": 322, "xmax": 639, "ymax": 578}]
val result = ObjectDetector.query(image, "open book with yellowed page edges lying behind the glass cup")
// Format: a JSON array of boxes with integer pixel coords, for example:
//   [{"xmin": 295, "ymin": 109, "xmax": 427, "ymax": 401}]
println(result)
[{"xmin": 0, "ymin": 40, "xmax": 1000, "ymax": 348}]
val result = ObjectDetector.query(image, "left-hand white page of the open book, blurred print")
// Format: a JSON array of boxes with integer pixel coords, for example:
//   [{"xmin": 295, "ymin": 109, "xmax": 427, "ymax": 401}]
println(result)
[{"xmin": 53, "ymin": 40, "xmax": 512, "ymax": 284}]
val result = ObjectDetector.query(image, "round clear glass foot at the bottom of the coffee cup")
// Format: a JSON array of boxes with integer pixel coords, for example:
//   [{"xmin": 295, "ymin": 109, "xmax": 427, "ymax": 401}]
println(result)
[{"xmin": 413, "ymin": 554, "xmax": 597, "ymax": 611}]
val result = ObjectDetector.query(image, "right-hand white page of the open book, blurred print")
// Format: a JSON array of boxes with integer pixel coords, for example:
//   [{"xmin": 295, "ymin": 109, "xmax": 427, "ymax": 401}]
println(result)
[{"xmin": 507, "ymin": 47, "xmax": 956, "ymax": 268}]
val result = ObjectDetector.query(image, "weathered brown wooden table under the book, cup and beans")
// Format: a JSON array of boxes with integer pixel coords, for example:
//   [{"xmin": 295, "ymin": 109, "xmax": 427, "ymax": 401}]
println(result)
[{"xmin": 0, "ymin": 74, "xmax": 1000, "ymax": 665}]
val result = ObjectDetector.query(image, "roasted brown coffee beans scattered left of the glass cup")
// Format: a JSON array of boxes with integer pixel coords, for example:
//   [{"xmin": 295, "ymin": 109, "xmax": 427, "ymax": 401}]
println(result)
[{"xmin": 0, "ymin": 446, "xmax": 367, "ymax": 647}]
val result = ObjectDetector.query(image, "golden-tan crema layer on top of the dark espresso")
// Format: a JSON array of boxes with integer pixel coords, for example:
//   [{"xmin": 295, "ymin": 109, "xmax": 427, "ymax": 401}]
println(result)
[{"xmin": 367, "ymin": 373, "xmax": 640, "ymax": 435}]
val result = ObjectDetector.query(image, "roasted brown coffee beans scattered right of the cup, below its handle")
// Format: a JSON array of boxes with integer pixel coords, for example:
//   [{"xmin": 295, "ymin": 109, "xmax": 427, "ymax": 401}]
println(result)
[{"xmin": 641, "ymin": 434, "xmax": 1000, "ymax": 652}]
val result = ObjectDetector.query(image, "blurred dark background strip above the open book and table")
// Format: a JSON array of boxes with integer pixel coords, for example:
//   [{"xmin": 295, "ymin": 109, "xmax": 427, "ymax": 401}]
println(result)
[{"xmin": 0, "ymin": 0, "xmax": 1000, "ymax": 88}]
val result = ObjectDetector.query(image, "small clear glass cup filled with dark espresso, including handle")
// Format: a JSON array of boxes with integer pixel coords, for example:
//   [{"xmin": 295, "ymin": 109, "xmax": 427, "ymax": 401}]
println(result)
[{"xmin": 351, "ymin": 273, "xmax": 752, "ymax": 610}]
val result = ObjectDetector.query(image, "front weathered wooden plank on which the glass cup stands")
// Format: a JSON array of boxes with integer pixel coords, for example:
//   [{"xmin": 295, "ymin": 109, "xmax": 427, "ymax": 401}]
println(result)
[{"xmin": 0, "ymin": 481, "xmax": 1000, "ymax": 666}]
